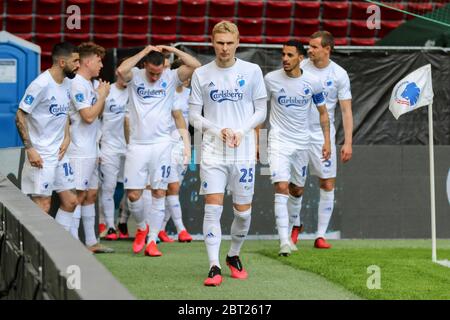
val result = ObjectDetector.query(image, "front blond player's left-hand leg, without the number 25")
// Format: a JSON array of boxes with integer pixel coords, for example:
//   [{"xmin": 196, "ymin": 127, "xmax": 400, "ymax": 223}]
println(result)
[{"xmin": 200, "ymin": 162, "xmax": 228, "ymax": 286}]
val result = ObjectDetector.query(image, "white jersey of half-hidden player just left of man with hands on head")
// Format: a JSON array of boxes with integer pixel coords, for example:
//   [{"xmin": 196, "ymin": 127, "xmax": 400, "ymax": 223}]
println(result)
[{"xmin": 100, "ymin": 83, "xmax": 128, "ymax": 153}]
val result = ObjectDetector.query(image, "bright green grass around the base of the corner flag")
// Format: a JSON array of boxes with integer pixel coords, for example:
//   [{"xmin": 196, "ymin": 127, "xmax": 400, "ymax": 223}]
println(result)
[{"xmin": 259, "ymin": 240, "xmax": 450, "ymax": 300}]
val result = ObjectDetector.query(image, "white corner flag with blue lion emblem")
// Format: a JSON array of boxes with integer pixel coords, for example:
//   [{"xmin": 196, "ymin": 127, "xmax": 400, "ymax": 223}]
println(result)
[{"xmin": 389, "ymin": 64, "xmax": 433, "ymax": 120}]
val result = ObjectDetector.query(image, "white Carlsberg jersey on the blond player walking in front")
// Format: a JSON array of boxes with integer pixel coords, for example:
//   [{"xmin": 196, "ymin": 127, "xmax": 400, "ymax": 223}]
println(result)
[{"xmin": 189, "ymin": 59, "xmax": 267, "ymax": 162}]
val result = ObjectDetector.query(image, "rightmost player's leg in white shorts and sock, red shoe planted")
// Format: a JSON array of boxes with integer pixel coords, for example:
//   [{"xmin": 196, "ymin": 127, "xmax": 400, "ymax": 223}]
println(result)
[{"xmin": 310, "ymin": 144, "xmax": 336, "ymax": 249}]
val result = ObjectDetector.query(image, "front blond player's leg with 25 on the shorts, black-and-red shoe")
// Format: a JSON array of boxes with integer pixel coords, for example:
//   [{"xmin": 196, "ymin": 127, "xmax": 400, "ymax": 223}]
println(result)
[{"xmin": 226, "ymin": 163, "xmax": 255, "ymax": 279}]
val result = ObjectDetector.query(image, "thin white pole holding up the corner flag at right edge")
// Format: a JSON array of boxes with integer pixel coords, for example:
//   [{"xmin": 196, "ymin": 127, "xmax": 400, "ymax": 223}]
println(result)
[{"xmin": 428, "ymin": 103, "xmax": 437, "ymax": 262}]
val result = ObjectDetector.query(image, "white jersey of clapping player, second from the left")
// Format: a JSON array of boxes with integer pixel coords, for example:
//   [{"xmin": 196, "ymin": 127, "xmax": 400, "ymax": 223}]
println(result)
[{"xmin": 67, "ymin": 74, "xmax": 100, "ymax": 158}]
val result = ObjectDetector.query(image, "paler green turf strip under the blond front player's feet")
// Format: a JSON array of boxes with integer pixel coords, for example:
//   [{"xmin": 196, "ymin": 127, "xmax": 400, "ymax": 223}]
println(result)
[{"xmin": 96, "ymin": 240, "xmax": 359, "ymax": 300}]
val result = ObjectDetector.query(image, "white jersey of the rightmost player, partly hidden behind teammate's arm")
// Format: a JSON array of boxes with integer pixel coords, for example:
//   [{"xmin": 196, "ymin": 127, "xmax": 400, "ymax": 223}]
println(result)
[{"xmin": 300, "ymin": 59, "xmax": 352, "ymax": 144}]
